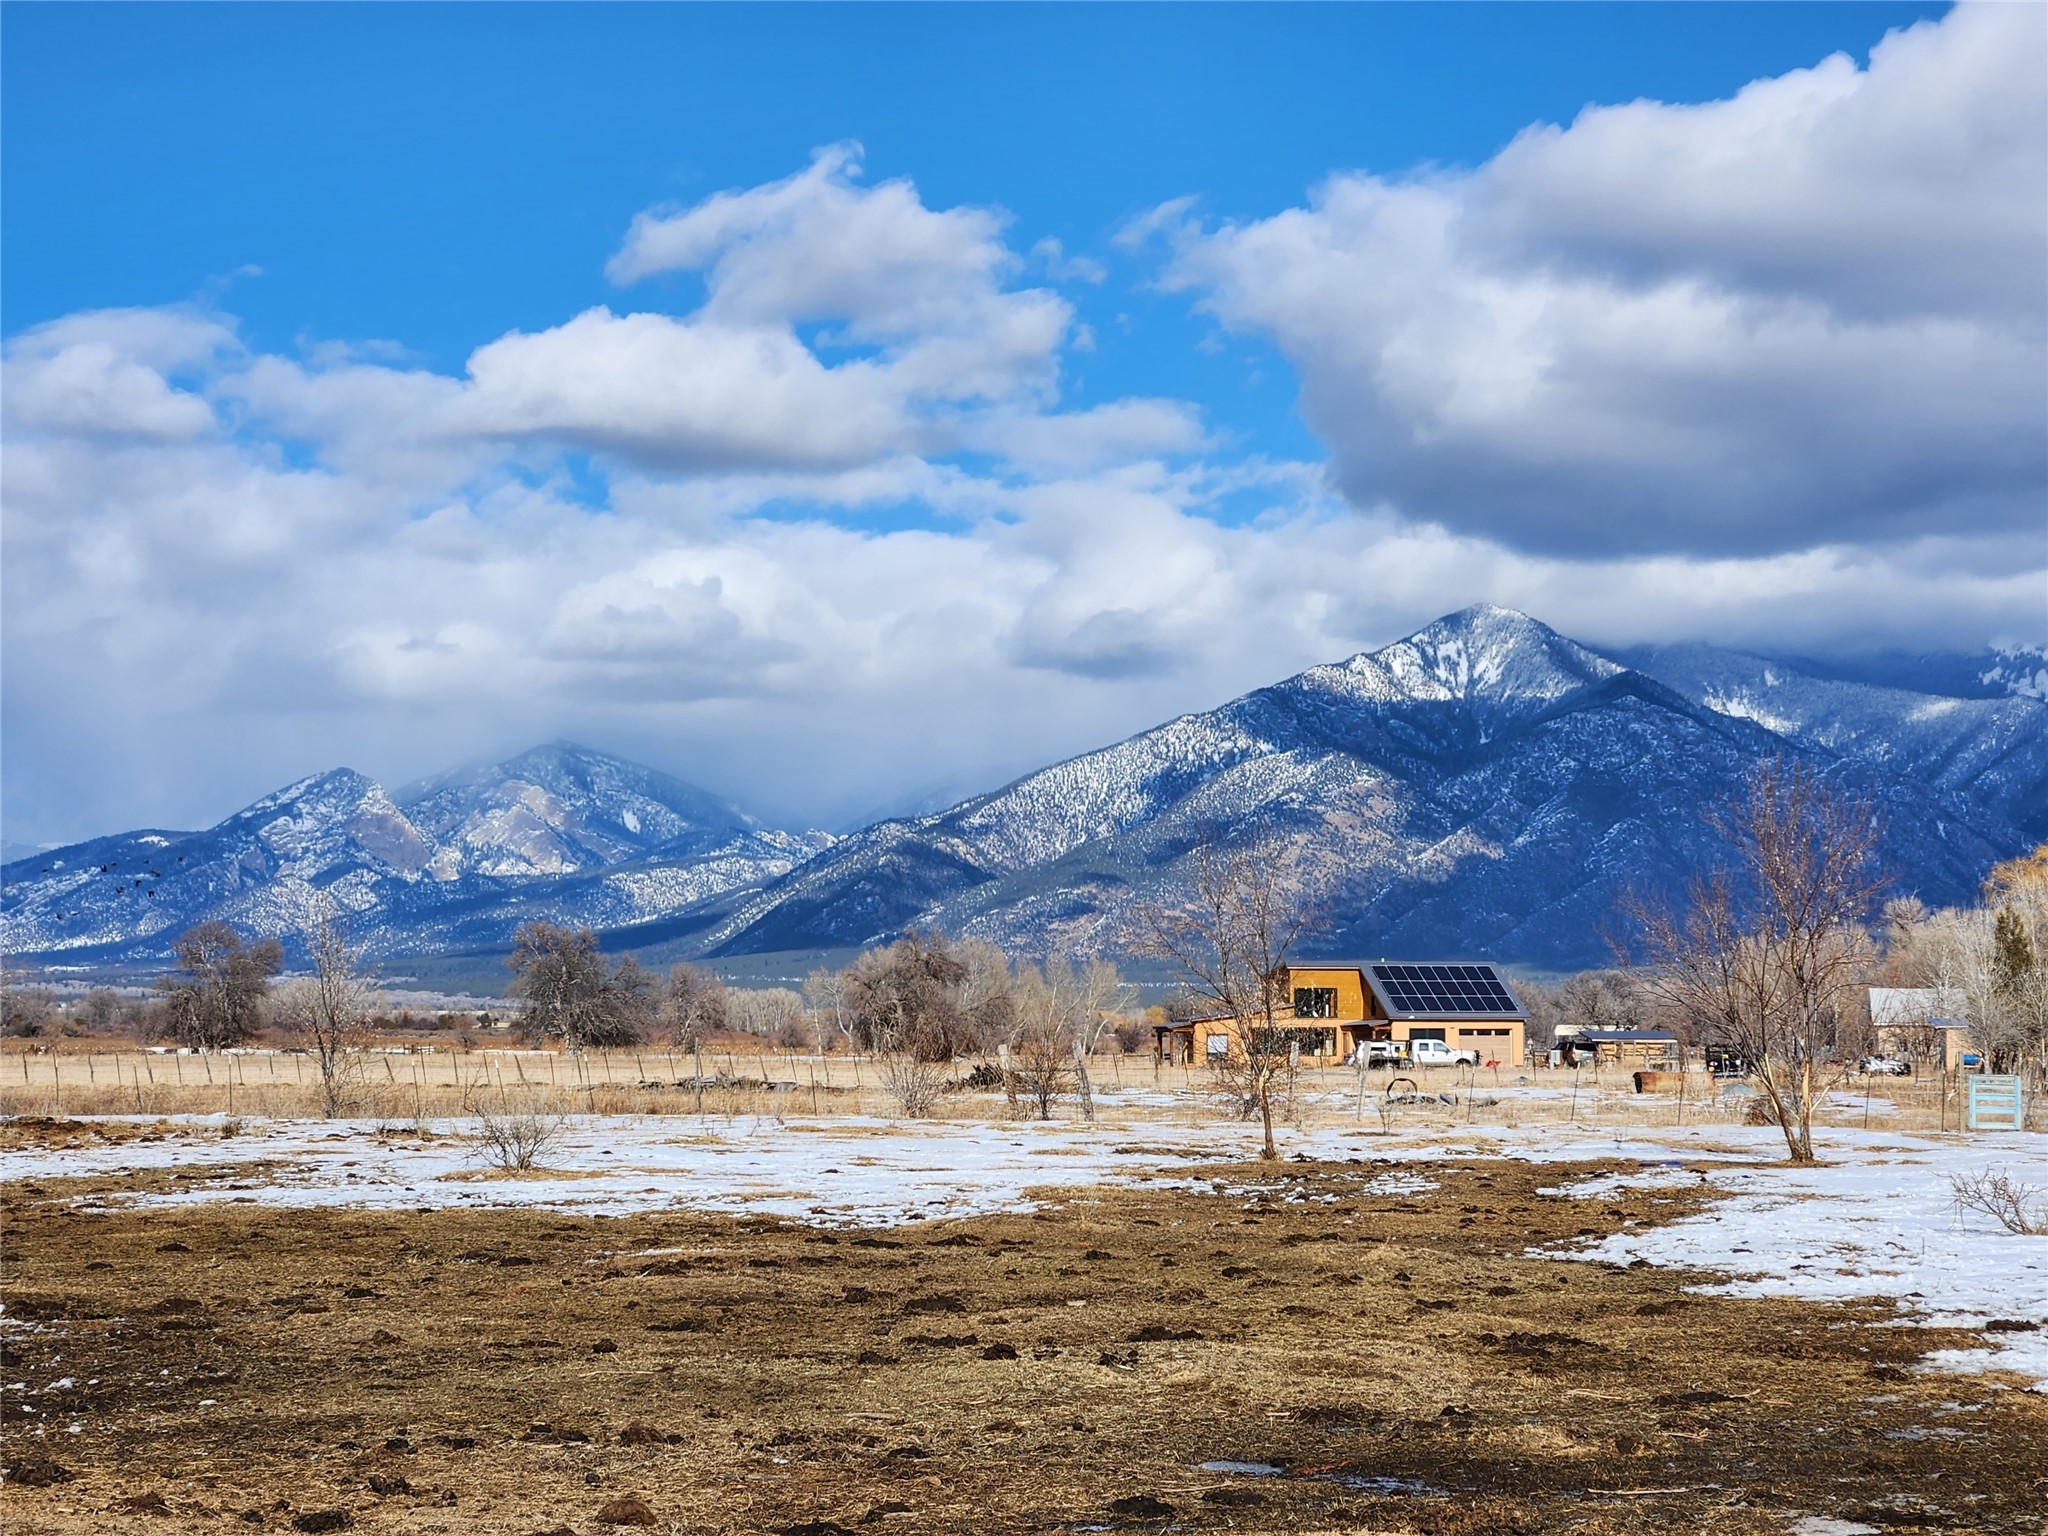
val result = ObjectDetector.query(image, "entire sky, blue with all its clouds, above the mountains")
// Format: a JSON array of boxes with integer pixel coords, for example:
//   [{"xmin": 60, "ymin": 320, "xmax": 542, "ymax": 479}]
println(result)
[{"xmin": 0, "ymin": 4, "xmax": 2048, "ymax": 840}]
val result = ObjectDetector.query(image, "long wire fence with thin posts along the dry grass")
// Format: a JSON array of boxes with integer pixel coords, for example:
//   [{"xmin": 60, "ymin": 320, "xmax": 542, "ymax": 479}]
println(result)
[{"xmin": 0, "ymin": 1047, "xmax": 2023, "ymax": 1133}]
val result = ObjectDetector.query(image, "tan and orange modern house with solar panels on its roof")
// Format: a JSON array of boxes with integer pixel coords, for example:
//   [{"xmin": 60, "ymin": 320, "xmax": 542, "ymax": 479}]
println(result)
[{"xmin": 1153, "ymin": 961, "xmax": 1528, "ymax": 1067}]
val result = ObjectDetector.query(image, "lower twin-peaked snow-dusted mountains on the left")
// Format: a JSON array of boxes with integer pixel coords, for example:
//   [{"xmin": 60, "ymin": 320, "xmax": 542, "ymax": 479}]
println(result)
[{"xmin": 0, "ymin": 743, "xmax": 829, "ymax": 963}]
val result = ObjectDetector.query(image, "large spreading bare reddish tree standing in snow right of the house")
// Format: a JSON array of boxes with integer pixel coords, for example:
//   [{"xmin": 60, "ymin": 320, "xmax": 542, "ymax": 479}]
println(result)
[{"xmin": 1628, "ymin": 758, "xmax": 1884, "ymax": 1163}]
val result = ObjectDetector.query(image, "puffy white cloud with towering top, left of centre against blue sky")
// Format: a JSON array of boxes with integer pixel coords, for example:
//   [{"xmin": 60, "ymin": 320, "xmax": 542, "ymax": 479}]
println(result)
[{"xmin": 197, "ymin": 145, "xmax": 1105, "ymax": 487}]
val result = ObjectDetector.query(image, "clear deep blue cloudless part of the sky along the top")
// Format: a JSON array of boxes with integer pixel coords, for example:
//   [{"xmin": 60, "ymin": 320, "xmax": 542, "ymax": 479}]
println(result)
[{"xmin": 0, "ymin": 4, "xmax": 1946, "ymax": 481}]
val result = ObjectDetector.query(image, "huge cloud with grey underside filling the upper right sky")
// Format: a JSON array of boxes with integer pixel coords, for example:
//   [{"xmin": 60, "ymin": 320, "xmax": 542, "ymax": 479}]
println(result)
[{"xmin": 1147, "ymin": 6, "xmax": 2048, "ymax": 557}]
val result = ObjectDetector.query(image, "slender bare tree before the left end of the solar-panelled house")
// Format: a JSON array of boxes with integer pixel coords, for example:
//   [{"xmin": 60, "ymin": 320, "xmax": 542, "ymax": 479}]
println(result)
[{"xmin": 1141, "ymin": 831, "xmax": 1311, "ymax": 1157}]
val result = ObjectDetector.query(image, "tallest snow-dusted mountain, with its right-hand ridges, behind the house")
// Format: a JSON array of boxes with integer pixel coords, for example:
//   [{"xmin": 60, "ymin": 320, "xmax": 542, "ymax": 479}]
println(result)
[{"xmin": 702, "ymin": 606, "xmax": 2048, "ymax": 965}]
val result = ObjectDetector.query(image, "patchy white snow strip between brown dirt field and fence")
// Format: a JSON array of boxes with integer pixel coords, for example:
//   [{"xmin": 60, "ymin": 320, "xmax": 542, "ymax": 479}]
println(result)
[{"xmin": 0, "ymin": 1102, "xmax": 2048, "ymax": 1389}]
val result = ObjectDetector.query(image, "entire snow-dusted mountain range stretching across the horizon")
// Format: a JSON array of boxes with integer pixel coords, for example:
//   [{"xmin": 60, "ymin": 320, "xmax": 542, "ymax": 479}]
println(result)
[{"xmin": 0, "ymin": 606, "xmax": 2048, "ymax": 967}]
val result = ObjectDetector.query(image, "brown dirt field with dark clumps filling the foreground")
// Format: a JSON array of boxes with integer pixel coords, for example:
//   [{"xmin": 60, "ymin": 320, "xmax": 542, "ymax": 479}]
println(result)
[{"xmin": 0, "ymin": 1163, "xmax": 2048, "ymax": 1536}]
